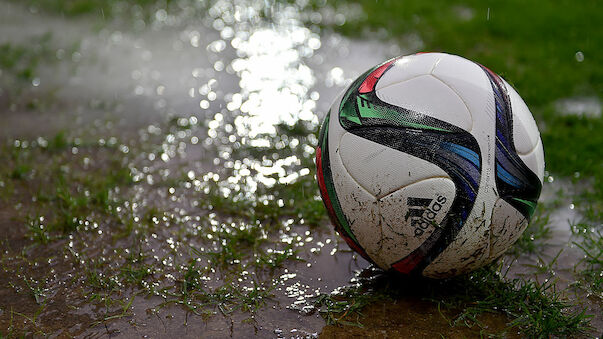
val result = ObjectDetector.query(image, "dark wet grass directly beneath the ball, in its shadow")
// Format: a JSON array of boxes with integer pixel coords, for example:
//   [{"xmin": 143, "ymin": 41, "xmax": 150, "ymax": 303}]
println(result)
[{"xmin": 315, "ymin": 265, "xmax": 591, "ymax": 338}]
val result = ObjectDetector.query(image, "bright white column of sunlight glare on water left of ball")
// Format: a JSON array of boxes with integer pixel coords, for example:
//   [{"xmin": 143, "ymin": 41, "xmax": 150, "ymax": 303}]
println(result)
[{"xmin": 202, "ymin": 1, "xmax": 321, "ymax": 199}]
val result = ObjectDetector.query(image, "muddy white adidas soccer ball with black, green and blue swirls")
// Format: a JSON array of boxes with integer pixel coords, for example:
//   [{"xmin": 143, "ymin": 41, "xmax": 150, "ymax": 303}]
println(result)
[{"xmin": 316, "ymin": 53, "xmax": 544, "ymax": 278}]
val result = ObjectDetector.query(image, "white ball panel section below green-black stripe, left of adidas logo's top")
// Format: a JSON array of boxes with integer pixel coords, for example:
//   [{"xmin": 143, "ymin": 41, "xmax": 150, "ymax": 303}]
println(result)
[{"xmin": 339, "ymin": 133, "xmax": 448, "ymax": 197}]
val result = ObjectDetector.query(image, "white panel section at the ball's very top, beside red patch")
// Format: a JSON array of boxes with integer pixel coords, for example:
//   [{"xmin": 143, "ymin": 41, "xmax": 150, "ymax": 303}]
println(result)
[{"xmin": 375, "ymin": 53, "xmax": 444, "ymax": 91}]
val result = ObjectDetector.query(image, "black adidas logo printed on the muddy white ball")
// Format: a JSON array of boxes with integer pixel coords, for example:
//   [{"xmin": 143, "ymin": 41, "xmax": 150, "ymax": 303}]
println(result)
[{"xmin": 404, "ymin": 196, "xmax": 446, "ymax": 237}]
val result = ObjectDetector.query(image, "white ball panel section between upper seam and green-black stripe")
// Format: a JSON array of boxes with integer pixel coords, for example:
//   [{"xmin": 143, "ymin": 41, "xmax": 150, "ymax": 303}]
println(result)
[{"xmin": 376, "ymin": 74, "xmax": 473, "ymax": 131}]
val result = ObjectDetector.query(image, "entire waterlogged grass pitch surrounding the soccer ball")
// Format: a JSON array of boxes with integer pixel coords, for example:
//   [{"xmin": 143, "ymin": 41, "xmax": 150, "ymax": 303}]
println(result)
[{"xmin": 0, "ymin": 0, "xmax": 603, "ymax": 338}]
